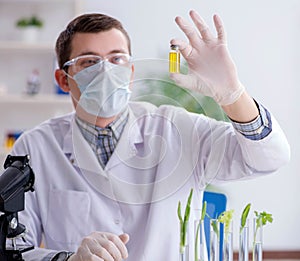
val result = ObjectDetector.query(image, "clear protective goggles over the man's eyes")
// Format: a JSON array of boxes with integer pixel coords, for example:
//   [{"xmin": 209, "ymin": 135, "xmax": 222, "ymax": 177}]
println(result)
[{"xmin": 62, "ymin": 53, "xmax": 132, "ymax": 75}]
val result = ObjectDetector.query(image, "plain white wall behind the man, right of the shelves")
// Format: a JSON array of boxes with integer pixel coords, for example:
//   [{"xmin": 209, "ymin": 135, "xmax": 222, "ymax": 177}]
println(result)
[{"xmin": 85, "ymin": 0, "xmax": 300, "ymax": 250}]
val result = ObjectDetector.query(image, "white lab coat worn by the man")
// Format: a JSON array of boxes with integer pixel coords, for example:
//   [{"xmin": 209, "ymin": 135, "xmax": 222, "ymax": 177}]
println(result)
[{"xmin": 12, "ymin": 103, "xmax": 290, "ymax": 261}]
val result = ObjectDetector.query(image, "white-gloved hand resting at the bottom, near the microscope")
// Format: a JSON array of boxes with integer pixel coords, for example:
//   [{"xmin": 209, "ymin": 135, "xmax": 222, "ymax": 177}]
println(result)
[{"xmin": 68, "ymin": 232, "xmax": 129, "ymax": 261}]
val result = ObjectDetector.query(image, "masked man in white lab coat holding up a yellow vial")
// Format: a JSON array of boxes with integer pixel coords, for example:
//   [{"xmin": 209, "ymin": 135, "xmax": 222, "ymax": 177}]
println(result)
[{"xmin": 13, "ymin": 11, "xmax": 290, "ymax": 261}]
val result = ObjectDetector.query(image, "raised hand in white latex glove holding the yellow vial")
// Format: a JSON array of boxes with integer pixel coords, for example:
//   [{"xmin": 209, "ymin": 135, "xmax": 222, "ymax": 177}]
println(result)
[{"xmin": 170, "ymin": 11, "xmax": 244, "ymax": 105}]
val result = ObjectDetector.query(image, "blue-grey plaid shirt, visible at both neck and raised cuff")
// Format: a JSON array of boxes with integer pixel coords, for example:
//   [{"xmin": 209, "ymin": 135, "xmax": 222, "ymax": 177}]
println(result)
[{"xmin": 76, "ymin": 103, "xmax": 272, "ymax": 168}]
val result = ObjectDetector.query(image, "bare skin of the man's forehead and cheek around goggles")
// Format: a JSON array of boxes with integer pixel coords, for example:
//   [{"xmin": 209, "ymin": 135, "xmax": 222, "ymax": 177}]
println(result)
[{"xmin": 68, "ymin": 28, "xmax": 129, "ymax": 106}]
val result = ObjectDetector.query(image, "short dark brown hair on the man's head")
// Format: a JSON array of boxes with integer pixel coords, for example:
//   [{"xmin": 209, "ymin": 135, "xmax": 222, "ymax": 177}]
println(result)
[{"xmin": 55, "ymin": 13, "xmax": 131, "ymax": 69}]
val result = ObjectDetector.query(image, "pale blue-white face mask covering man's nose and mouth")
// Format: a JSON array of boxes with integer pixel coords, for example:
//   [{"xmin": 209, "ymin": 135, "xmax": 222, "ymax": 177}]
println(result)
[{"xmin": 73, "ymin": 61, "xmax": 132, "ymax": 118}]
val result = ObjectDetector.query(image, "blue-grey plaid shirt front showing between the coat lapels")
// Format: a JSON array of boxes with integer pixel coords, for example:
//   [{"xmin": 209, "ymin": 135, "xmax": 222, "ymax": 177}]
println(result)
[{"xmin": 76, "ymin": 109, "xmax": 128, "ymax": 168}]
